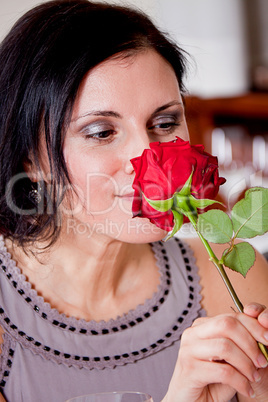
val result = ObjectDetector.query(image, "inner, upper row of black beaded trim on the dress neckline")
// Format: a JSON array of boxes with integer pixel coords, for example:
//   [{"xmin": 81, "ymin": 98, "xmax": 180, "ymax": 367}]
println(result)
[{"xmin": 0, "ymin": 242, "xmax": 171, "ymax": 336}]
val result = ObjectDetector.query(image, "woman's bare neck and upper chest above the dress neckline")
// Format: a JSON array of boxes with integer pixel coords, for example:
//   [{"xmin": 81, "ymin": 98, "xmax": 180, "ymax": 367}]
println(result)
[{"xmin": 6, "ymin": 231, "xmax": 159, "ymax": 321}]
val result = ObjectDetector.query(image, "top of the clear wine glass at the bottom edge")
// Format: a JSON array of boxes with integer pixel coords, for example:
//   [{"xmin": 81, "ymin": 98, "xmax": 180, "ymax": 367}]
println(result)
[{"xmin": 66, "ymin": 391, "xmax": 153, "ymax": 402}]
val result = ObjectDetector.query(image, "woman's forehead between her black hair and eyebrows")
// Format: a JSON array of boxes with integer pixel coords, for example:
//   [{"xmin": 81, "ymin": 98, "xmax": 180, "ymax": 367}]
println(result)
[{"xmin": 73, "ymin": 50, "xmax": 180, "ymax": 118}]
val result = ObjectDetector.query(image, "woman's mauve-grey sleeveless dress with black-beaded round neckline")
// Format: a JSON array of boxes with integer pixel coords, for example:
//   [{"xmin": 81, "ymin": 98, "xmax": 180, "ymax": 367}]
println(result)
[{"xmin": 0, "ymin": 238, "xmax": 205, "ymax": 402}]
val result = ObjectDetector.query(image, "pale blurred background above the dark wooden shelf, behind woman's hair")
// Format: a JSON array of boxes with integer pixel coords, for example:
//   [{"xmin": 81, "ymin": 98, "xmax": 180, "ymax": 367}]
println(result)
[{"xmin": 0, "ymin": 0, "xmax": 268, "ymax": 97}]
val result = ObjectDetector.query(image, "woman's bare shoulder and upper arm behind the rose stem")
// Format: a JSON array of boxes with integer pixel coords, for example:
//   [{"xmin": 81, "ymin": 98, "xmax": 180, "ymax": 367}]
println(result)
[{"xmin": 187, "ymin": 238, "xmax": 268, "ymax": 315}]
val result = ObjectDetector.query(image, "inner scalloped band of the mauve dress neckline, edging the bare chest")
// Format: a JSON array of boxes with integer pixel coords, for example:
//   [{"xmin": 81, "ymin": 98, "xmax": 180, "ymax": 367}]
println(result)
[{"xmin": 0, "ymin": 236, "xmax": 171, "ymax": 335}]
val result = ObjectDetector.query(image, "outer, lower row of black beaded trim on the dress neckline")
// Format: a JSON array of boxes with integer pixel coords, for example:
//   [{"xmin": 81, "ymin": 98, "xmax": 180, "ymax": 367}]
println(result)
[{"xmin": 0, "ymin": 241, "xmax": 199, "ymax": 370}]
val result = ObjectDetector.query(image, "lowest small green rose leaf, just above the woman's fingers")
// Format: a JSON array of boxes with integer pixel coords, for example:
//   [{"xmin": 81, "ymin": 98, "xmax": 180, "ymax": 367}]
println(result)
[{"xmin": 222, "ymin": 242, "xmax": 256, "ymax": 277}]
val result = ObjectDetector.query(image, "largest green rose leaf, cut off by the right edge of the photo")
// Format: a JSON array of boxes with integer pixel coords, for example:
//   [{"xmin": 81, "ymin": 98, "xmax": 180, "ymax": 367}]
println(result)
[{"xmin": 231, "ymin": 187, "xmax": 268, "ymax": 239}]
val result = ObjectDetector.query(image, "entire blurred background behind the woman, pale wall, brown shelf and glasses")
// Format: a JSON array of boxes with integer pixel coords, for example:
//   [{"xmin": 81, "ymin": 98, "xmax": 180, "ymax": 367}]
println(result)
[{"xmin": 0, "ymin": 0, "xmax": 268, "ymax": 252}]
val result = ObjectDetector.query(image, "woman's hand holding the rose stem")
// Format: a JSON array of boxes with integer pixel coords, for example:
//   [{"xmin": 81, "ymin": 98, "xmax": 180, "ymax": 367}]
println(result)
[{"xmin": 164, "ymin": 307, "xmax": 268, "ymax": 402}]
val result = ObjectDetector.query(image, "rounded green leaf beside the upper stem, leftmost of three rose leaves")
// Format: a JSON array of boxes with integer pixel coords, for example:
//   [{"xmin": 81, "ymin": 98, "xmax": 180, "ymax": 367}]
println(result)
[{"xmin": 197, "ymin": 209, "xmax": 233, "ymax": 244}]
